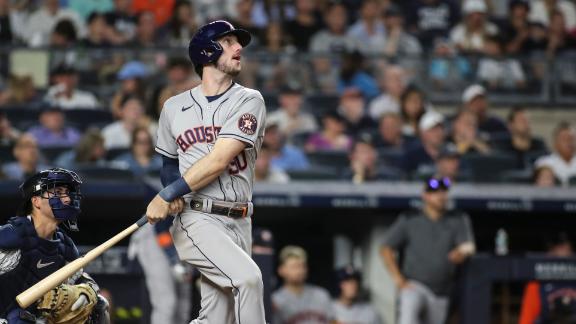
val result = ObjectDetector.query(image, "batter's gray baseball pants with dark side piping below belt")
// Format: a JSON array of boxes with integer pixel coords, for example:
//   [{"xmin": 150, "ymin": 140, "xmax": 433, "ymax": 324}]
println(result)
[{"xmin": 170, "ymin": 206, "xmax": 265, "ymax": 324}]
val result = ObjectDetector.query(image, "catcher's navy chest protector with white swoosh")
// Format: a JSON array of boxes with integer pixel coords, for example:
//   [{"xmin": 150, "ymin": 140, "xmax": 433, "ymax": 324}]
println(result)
[{"xmin": 0, "ymin": 217, "xmax": 78, "ymax": 317}]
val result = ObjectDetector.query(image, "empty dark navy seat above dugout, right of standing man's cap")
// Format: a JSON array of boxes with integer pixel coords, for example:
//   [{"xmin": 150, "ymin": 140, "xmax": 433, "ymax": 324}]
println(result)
[{"xmin": 461, "ymin": 153, "xmax": 517, "ymax": 182}]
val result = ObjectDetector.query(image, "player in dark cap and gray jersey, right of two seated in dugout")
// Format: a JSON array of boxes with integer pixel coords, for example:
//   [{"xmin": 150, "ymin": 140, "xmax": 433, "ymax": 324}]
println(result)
[{"xmin": 332, "ymin": 265, "xmax": 381, "ymax": 324}]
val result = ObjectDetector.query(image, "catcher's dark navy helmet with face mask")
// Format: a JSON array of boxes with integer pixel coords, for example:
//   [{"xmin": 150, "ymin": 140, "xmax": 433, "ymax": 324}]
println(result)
[{"xmin": 20, "ymin": 168, "xmax": 82, "ymax": 231}]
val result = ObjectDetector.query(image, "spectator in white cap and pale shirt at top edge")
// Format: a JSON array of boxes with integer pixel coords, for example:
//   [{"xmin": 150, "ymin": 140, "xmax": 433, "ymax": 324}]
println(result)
[{"xmin": 450, "ymin": 0, "xmax": 498, "ymax": 53}]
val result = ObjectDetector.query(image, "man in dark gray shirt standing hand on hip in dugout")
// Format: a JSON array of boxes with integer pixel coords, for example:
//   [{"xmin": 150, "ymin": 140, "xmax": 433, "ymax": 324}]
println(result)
[{"xmin": 381, "ymin": 177, "xmax": 475, "ymax": 324}]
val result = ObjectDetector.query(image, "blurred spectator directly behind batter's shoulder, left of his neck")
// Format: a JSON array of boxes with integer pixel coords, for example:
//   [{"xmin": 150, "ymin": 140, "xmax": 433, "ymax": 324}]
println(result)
[{"xmin": 157, "ymin": 57, "xmax": 199, "ymax": 115}]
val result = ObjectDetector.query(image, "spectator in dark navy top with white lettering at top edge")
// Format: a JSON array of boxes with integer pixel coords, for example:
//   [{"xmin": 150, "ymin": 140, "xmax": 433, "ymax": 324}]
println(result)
[{"xmin": 405, "ymin": 0, "xmax": 460, "ymax": 49}]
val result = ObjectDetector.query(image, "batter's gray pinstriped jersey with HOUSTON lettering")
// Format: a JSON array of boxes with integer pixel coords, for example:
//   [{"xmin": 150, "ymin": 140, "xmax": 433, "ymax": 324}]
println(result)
[{"xmin": 156, "ymin": 83, "xmax": 266, "ymax": 202}]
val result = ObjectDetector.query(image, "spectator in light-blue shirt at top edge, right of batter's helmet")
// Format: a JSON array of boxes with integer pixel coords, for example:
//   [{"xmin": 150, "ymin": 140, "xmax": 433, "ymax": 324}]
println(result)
[{"xmin": 348, "ymin": 0, "xmax": 386, "ymax": 54}]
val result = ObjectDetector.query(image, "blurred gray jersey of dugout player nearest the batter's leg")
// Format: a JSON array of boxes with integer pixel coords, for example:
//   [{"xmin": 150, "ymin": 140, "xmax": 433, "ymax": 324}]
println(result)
[{"xmin": 272, "ymin": 285, "xmax": 334, "ymax": 324}]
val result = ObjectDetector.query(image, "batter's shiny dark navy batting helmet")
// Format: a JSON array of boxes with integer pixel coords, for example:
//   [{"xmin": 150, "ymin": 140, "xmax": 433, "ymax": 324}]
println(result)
[{"xmin": 188, "ymin": 20, "xmax": 252, "ymax": 67}]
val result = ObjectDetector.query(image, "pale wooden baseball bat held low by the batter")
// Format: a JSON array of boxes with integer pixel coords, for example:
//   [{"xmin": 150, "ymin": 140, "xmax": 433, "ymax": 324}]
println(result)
[{"xmin": 16, "ymin": 215, "xmax": 148, "ymax": 308}]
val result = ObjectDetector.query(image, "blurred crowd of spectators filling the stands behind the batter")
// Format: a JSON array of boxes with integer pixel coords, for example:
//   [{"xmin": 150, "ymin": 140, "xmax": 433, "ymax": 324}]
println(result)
[{"xmin": 0, "ymin": 0, "xmax": 576, "ymax": 186}]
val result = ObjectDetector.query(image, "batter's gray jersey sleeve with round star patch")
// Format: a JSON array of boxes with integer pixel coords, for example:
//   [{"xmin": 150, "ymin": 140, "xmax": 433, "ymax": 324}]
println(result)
[{"xmin": 218, "ymin": 95, "xmax": 266, "ymax": 147}]
